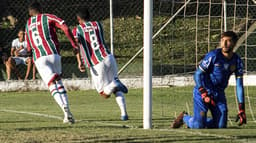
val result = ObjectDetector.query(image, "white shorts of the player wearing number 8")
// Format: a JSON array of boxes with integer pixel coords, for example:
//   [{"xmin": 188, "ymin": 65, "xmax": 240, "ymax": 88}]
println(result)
[{"xmin": 90, "ymin": 54, "xmax": 117, "ymax": 93}]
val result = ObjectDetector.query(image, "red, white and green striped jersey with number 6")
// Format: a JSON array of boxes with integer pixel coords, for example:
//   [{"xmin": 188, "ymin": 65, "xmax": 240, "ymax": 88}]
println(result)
[{"xmin": 25, "ymin": 14, "xmax": 64, "ymax": 61}]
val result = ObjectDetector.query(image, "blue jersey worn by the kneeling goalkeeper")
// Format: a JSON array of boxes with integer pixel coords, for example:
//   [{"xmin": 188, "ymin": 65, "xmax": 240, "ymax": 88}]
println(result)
[{"xmin": 195, "ymin": 48, "xmax": 243, "ymax": 93}]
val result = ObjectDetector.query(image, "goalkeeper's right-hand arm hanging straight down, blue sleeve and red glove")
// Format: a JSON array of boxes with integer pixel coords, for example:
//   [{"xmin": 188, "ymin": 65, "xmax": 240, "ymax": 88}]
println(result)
[{"xmin": 235, "ymin": 60, "xmax": 246, "ymax": 126}]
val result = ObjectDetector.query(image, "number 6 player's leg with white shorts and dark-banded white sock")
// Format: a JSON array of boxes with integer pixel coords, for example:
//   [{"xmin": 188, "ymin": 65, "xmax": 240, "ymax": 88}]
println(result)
[{"xmin": 35, "ymin": 55, "xmax": 74, "ymax": 123}]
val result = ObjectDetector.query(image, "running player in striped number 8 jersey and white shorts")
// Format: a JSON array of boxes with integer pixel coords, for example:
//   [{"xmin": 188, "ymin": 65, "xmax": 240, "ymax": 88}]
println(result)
[{"xmin": 73, "ymin": 8, "xmax": 128, "ymax": 121}]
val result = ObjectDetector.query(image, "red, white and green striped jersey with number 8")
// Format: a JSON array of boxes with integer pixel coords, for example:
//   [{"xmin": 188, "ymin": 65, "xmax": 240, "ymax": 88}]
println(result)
[{"xmin": 73, "ymin": 21, "xmax": 110, "ymax": 68}]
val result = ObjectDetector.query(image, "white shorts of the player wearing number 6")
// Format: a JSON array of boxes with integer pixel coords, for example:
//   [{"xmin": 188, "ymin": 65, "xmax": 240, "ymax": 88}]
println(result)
[{"xmin": 35, "ymin": 54, "xmax": 61, "ymax": 85}]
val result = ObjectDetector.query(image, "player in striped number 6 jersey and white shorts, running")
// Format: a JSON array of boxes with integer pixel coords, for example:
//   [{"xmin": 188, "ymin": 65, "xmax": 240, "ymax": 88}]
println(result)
[{"xmin": 26, "ymin": 2, "xmax": 84, "ymax": 123}]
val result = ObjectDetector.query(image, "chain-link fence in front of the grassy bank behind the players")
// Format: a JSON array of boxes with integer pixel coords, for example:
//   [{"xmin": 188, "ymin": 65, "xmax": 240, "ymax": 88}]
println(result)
[{"xmin": 0, "ymin": 0, "xmax": 256, "ymax": 80}]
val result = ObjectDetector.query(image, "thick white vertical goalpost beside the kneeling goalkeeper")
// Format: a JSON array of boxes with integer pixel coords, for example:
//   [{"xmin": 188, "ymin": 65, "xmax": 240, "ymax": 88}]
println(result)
[{"xmin": 143, "ymin": 0, "xmax": 153, "ymax": 129}]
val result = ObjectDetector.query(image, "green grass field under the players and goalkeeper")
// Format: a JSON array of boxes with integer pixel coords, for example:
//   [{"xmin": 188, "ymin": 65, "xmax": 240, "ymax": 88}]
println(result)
[{"xmin": 0, "ymin": 87, "xmax": 256, "ymax": 143}]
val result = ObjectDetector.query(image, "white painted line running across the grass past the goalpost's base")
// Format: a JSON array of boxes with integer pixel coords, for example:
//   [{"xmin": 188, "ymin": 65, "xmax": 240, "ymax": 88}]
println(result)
[{"xmin": 0, "ymin": 109, "xmax": 248, "ymax": 139}]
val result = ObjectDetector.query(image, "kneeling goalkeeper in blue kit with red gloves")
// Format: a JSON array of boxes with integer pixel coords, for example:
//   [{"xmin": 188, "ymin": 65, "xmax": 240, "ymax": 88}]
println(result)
[{"xmin": 172, "ymin": 31, "xmax": 246, "ymax": 129}]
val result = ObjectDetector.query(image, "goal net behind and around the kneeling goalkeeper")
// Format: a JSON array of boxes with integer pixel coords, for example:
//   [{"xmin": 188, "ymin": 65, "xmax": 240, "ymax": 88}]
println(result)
[{"xmin": 146, "ymin": 0, "xmax": 256, "ymax": 125}]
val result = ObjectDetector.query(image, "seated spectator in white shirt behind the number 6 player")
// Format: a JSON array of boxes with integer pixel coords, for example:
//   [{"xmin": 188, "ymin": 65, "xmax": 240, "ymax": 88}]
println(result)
[{"xmin": 5, "ymin": 30, "xmax": 35, "ymax": 80}]
